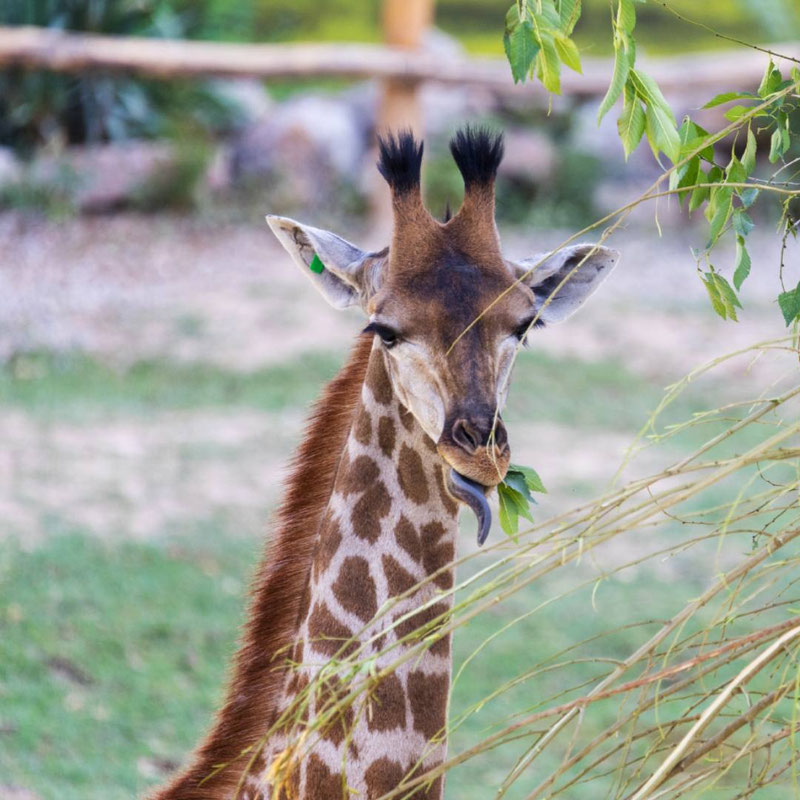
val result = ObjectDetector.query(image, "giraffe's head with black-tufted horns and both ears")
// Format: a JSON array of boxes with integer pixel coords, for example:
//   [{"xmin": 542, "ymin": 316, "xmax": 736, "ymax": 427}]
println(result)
[{"xmin": 267, "ymin": 128, "xmax": 619, "ymax": 524}]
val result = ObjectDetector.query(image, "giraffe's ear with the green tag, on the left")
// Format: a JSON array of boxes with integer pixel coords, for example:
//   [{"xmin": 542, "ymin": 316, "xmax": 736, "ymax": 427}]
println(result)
[{"xmin": 267, "ymin": 214, "xmax": 387, "ymax": 308}]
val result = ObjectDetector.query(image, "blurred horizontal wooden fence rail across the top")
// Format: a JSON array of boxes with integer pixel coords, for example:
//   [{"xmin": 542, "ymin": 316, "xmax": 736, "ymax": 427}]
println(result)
[{"xmin": 0, "ymin": 26, "xmax": 800, "ymax": 99}]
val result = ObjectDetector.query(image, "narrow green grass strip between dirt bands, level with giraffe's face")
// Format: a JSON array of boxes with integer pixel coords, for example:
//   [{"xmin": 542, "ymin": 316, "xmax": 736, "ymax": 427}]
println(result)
[{"xmin": 0, "ymin": 346, "xmax": 700, "ymax": 430}]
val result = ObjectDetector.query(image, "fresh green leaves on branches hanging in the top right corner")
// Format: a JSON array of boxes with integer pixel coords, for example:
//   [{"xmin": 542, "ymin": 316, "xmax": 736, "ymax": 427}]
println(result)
[{"xmin": 496, "ymin": 0, "xmax": 800, "ymax": 325}]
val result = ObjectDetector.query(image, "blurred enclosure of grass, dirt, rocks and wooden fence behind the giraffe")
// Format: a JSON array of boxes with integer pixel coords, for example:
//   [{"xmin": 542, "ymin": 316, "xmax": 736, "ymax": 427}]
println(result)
[{"xmin": 0, "ymin": 0, "xmax": 800, "ymax": 800}]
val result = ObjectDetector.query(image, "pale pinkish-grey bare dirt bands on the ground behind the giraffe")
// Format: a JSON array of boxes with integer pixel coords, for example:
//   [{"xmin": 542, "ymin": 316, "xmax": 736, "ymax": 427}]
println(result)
[{"xmin": 0, "ymin": 213, "xmax": 797, "ymax": 542}]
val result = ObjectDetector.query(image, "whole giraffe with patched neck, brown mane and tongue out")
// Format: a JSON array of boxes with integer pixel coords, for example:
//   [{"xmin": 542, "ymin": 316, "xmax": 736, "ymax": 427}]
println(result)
[{"xmin": 152, "ymin": 128, "xmax": 619, "ymax": 800}]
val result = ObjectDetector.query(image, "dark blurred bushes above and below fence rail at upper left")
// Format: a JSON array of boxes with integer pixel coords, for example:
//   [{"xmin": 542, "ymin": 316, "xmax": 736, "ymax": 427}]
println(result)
[{"xmin": 0, "ymin": 0, "xmax": 244, "ymax": 152}]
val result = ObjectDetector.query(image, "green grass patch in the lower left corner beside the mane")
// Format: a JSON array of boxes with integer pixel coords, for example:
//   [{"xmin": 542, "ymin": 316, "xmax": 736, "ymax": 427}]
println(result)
[{"xmin": 0, "ymin": 531, "xmax": 258, "ymax": 800}]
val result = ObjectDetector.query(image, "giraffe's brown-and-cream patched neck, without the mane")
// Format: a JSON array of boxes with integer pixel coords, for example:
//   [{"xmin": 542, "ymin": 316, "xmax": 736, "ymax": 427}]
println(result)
[{"xmin": 251, "ymin": 345, "xmax": 458, "ymax": 800}]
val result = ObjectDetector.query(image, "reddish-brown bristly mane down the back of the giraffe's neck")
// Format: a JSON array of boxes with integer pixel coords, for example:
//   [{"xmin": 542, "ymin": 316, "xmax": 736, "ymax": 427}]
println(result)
[{"xmin": 151, "ymin": 335, "xmax": 373, "ymax": 800}]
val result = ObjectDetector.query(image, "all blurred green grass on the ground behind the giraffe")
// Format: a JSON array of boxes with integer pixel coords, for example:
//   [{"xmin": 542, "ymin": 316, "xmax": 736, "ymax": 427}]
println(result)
[{"xmin": 0, "ymin": 337, "xmax": 788, "ymax": 800}]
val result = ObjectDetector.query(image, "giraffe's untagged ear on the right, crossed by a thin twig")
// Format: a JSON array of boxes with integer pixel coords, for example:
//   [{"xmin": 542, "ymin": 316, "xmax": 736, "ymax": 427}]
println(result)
[{"xmin": 507, "ymin": 244, "xmax": 619, "ymax": 323}]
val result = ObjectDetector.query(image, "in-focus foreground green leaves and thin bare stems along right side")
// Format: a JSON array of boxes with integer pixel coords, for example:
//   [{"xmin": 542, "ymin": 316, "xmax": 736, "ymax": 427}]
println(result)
[{"xmin": 484, "ymin": 0, "xmax": 800, "ymax": 800}]
